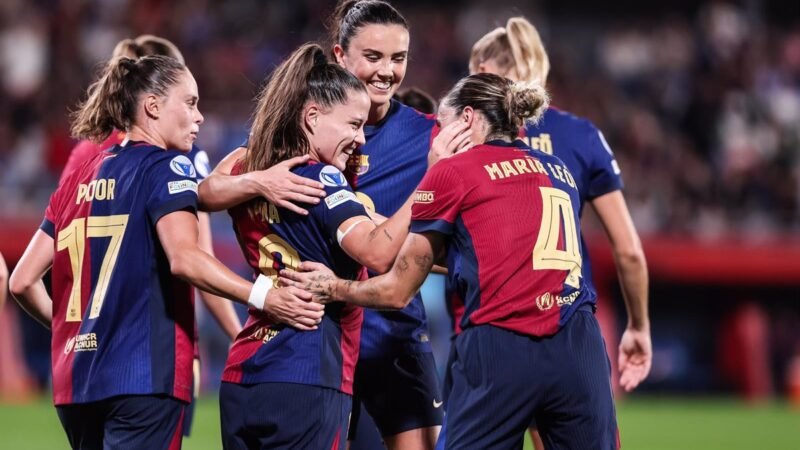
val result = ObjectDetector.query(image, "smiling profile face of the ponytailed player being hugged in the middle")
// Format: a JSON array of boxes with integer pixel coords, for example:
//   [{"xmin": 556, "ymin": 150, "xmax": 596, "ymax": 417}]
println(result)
[{"xmin": 305, "ymin": 90, "xmax": 370, "ymax": 171}]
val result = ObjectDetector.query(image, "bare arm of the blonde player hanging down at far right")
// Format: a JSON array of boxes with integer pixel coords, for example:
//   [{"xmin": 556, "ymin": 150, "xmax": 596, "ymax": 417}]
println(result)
[{"xmin": 592, "ymin": 190, "xmax": 653, "ymax": 391}]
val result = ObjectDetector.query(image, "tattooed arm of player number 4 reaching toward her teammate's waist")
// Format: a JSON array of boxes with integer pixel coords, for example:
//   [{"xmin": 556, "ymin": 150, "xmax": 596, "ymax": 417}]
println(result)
[{"xmin": 281, "ymin": 232, "xmax": 444, "ymax": 309}]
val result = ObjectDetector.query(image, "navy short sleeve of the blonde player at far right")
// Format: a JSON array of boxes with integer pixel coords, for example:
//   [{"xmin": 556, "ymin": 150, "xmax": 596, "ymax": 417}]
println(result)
[{"xmin": 579, "ymin": 124, "xmax": 623, "ymax": 200}]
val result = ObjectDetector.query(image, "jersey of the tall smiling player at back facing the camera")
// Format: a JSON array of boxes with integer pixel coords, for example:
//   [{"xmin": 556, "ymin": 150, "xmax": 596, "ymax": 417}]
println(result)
[{"xmin": 348, "ymin": 100, "xmax": 438, "ymax": 359}]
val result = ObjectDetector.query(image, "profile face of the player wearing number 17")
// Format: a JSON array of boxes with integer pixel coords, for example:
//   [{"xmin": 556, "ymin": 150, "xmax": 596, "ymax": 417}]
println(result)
[{"xmin": 156, "ymin": 70, "xmax": 203, "ymax": 152}]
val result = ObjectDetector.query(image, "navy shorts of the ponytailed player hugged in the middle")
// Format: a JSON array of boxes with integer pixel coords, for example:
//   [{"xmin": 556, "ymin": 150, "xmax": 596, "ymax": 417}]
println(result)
[{"xmin": 219, "ymin": 383, "xmax": 353, "ymax": 450}]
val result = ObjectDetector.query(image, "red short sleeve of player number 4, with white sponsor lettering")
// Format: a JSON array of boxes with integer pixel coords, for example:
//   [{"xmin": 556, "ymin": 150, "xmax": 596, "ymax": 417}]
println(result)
[{"xmin": 411, "ymin": 160, "xmax": 464, "ymax": 234}]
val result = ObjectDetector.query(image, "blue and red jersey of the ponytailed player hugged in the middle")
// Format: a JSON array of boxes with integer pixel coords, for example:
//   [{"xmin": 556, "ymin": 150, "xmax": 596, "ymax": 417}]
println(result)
[{"xmin": 222, "ymin": 163, "xmax": 367, "ymax": 394}]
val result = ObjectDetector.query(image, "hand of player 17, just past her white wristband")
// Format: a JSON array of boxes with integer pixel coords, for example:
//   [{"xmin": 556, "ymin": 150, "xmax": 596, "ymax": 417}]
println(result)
[{"xmin": 263, "ymin": 286, "xmax": 325, "ymax": 331}]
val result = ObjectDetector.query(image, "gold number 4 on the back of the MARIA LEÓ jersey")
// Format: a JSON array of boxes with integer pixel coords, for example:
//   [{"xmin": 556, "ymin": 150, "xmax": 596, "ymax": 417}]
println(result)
[{"xmin": 533, "ymin": 186, "xmax": 583, "ymax": 289}]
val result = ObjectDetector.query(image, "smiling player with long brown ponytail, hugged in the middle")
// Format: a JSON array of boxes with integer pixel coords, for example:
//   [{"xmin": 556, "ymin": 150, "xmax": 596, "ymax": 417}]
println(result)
[{"xmin": 209, "ymin": 40, "xmax": 446, "ymax": 449}]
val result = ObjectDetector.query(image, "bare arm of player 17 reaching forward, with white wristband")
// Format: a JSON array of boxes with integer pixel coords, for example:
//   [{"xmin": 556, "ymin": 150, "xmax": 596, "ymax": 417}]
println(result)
[{"xmin": 156, "ymin": 210, "xmax": 324, "ymax": 330}]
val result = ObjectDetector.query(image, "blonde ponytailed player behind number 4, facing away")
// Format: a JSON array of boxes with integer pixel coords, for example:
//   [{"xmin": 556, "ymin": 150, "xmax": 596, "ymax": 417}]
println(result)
[{"xmin": 469, "ymin": 17, "xmax": 653, "ymax": 398}]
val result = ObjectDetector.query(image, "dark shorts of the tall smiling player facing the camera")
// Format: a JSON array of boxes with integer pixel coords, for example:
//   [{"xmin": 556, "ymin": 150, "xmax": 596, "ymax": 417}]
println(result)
[{"xmin": 350, "ymin": 352, "xmax": 444, "ymax": 437}]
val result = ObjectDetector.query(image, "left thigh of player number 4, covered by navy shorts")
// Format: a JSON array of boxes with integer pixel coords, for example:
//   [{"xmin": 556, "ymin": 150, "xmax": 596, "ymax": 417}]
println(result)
[{"xmin": 439, "ymin": 326, "xmax": 539, "ymax": 449}]
